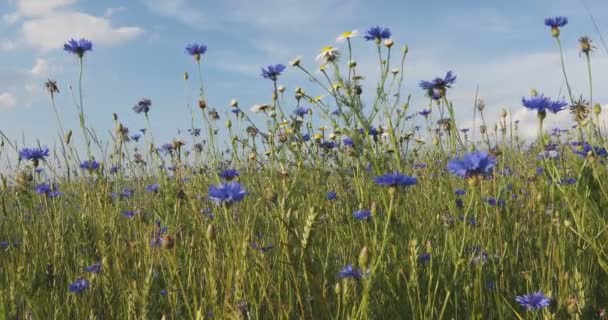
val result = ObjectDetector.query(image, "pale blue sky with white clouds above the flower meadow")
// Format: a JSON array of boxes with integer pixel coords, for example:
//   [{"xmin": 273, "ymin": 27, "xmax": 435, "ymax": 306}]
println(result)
[{"xmin": 0, "ymin": 0, "xmax": 608, "ymax": 151}]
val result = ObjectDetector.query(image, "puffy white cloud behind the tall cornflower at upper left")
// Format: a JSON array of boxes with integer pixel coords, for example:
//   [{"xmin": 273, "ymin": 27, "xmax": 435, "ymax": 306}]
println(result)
[{"xmin": 21, "ymin": 12, "xmax": 143, "ymax": 51}]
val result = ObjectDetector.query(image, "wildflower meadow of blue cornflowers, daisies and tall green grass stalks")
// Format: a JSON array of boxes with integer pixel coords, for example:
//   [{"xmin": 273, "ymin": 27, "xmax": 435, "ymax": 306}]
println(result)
[{"xmin": 0, "ymin": 9, "xmax": 608, "ymax": 319}]
